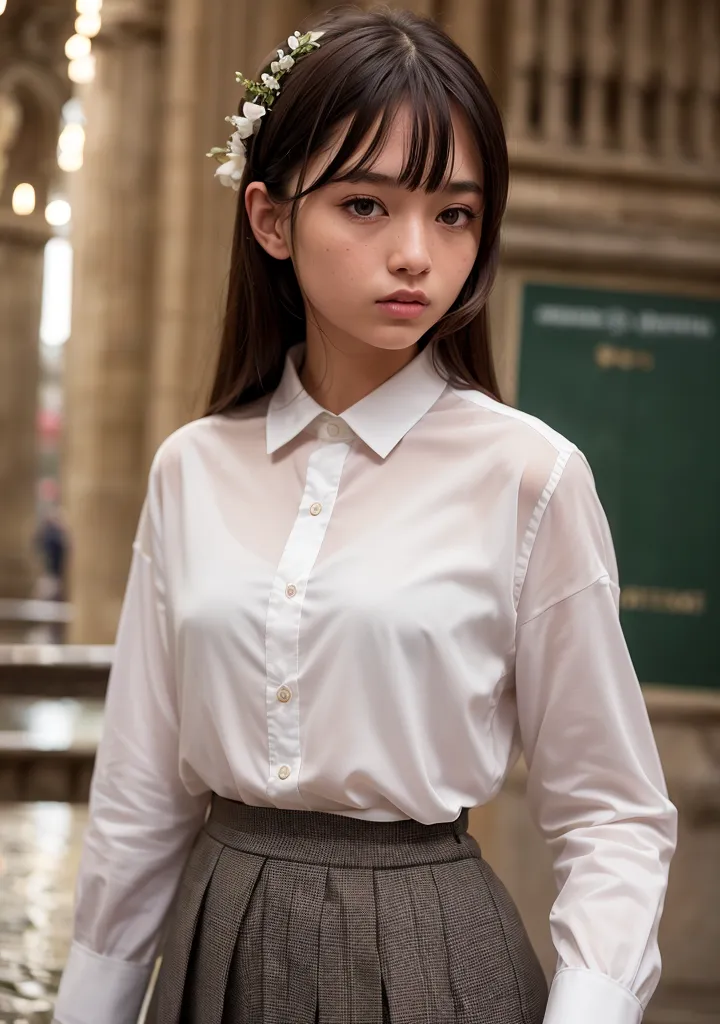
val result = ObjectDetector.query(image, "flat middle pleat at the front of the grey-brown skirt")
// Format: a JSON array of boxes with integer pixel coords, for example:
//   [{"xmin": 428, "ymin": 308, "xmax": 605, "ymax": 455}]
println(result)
[{"xmin": 317, "ymin": 867, "xmax": 383, "ymax": 1024}]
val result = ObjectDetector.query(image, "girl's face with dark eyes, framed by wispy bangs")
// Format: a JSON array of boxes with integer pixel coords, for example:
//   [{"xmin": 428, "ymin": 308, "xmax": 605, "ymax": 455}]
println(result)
[{"xmin": 285, "ymin": 103, "xmax": 482, "ymax": 350}]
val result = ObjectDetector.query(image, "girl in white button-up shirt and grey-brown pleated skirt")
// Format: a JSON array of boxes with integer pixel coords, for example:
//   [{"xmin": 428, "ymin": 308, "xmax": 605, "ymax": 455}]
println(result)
[{"xmin": 56, "ymin": 10, "xmax": 675, "ymax": 1024}]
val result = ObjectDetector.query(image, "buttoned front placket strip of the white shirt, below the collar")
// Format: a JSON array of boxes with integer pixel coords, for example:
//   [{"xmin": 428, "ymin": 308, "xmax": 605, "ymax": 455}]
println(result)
[{"xmin": 265, "ymin": 424, "xmax": 350, "ymax": 807}]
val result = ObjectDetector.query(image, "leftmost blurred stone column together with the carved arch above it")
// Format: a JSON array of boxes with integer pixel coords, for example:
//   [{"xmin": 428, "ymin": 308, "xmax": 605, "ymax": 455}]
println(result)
[{"xmin": 0, "ymin": 34, "xmax": 72, "ymax": 598}]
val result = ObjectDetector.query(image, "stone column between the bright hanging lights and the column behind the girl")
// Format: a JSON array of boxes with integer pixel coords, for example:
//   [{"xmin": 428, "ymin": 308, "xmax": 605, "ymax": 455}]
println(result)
[{"xmin": 63, "ymin": 0, "xmax": 163, "ymax": 643}]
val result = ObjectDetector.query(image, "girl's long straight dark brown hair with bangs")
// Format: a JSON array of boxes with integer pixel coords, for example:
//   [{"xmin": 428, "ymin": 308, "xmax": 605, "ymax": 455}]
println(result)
[{"xmin": 206, "ymin": 7, "xmax": 508, "ymax": 415}]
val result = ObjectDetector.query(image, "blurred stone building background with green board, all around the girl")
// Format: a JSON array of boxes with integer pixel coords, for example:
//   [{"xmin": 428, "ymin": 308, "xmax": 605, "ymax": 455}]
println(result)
[{"xmin": 0, "ymin": 0, "xmax": 720, "ymax": 1024}]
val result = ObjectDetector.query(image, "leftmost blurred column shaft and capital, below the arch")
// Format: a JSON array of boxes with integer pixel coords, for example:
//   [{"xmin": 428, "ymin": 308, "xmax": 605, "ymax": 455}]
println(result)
[{"xmin": 0, "ymin": 209, "xmax": 49, "ymax": 598}]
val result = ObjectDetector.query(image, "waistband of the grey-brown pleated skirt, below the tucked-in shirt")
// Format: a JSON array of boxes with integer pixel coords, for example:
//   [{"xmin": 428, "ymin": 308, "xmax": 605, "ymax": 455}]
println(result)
[{"xmin": 205, "ymin": 795, "xmax": 479, "ymax": 868}]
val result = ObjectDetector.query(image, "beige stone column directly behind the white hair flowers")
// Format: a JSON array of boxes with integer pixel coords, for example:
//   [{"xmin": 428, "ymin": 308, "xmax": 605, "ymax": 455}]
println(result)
[{"xmin": 146, "ymin": 0, "xmax": 312, "ymax": 460}]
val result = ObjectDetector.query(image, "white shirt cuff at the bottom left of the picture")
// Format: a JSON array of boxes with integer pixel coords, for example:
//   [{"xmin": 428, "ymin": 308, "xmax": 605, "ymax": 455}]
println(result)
[{"xmin": 53, "ymin": 942, "xmax": 154, "ymax": 1024}]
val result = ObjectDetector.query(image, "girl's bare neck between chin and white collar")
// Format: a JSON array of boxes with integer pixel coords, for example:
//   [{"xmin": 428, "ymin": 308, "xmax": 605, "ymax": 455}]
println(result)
[{"xmin": 300, "ymin": 337, "xmax": 418, "ymax": 416}]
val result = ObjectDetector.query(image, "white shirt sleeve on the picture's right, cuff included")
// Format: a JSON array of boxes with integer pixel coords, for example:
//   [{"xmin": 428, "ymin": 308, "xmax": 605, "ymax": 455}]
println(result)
[{"xmin": 516, "ymin": 453, "xmax": 676, "ymax": 1024}]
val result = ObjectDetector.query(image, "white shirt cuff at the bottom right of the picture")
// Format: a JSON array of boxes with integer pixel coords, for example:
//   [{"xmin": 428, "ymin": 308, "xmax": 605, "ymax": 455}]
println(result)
[{"xmin": 544, "ymin": 968, "xmax": 643, "ymax": 1024}]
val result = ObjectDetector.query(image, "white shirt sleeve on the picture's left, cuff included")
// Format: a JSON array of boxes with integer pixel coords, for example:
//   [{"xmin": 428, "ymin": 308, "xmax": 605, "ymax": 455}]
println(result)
[{"xmin": 55, "ymin": 466, "xmax": 208, "ymax": 1024}]
